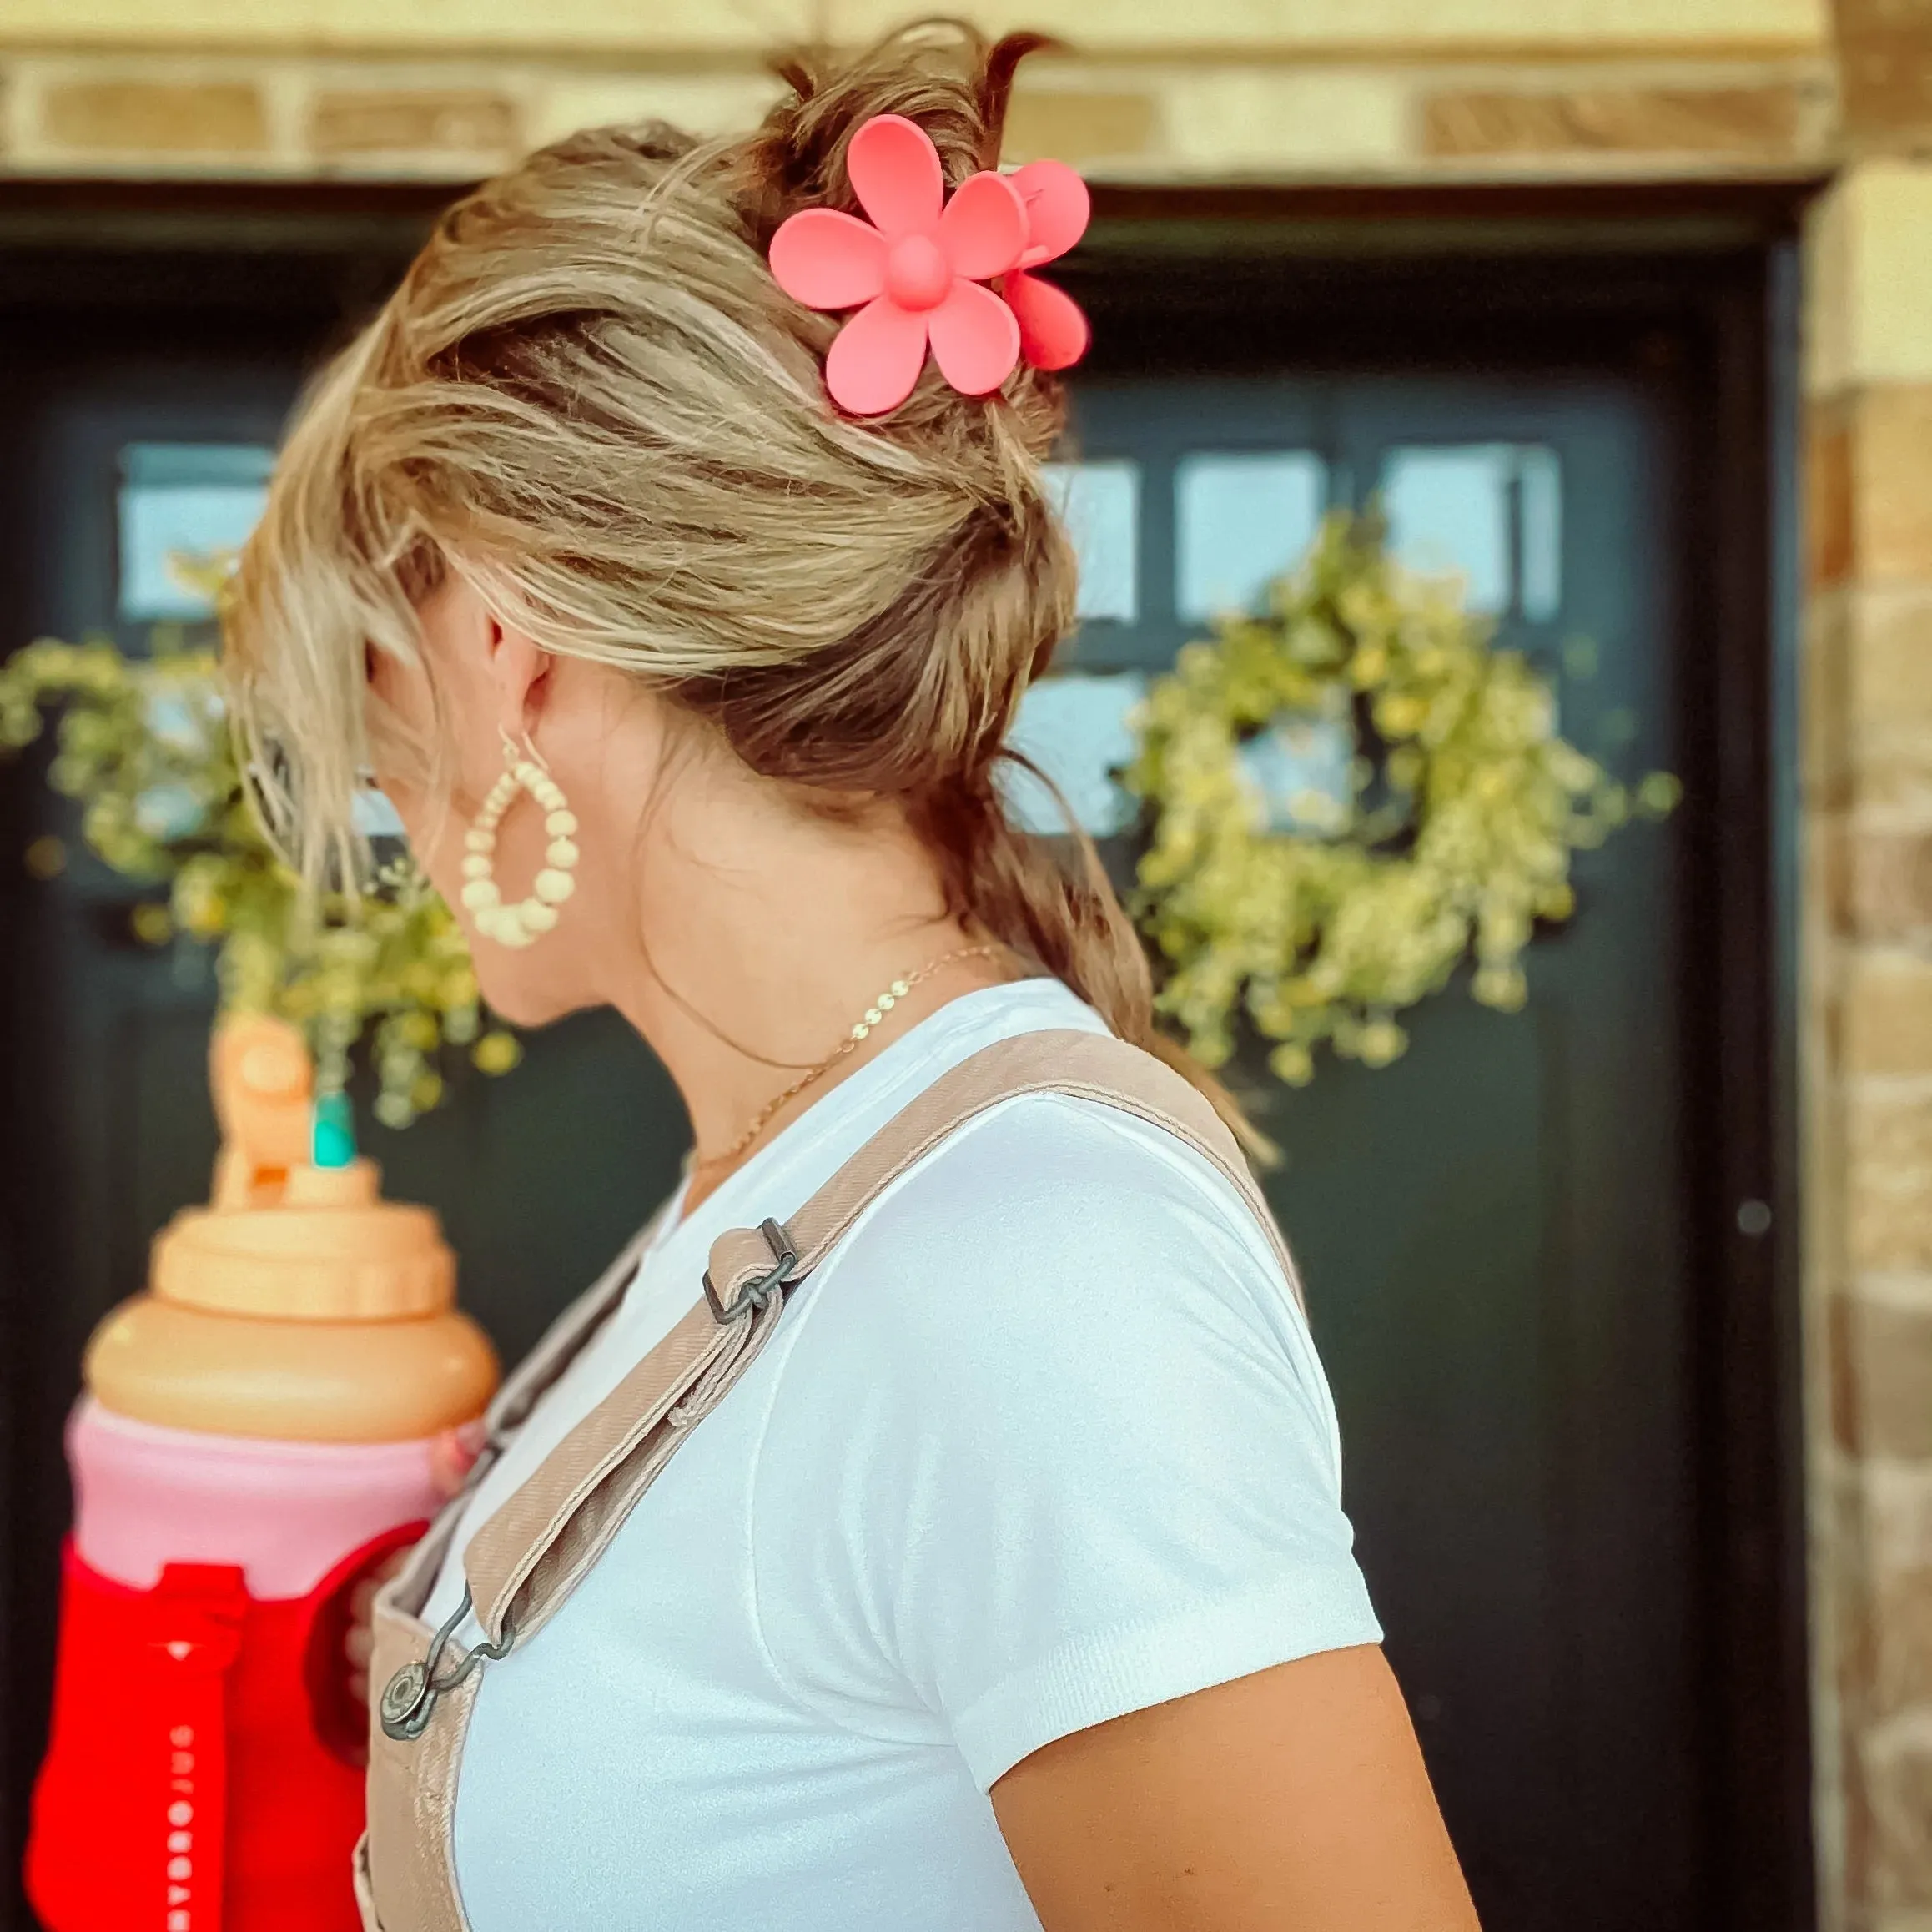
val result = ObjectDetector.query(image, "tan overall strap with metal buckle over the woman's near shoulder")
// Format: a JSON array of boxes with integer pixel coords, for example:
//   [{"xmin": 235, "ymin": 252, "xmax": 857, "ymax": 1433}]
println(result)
[{"xmin": 451, "ymin": 1029, "xmax": 1301, "ymax": 1646}]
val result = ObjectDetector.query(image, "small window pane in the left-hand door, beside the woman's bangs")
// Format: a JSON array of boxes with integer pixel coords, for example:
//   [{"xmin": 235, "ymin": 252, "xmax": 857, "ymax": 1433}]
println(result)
[{"xmin": 120, "ymin": 442, "xmax": 274, "ymax": 624}]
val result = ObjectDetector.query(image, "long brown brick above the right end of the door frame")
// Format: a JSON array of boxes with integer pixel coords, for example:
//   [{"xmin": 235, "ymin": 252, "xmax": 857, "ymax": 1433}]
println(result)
[{"xmin": 1422, "ymin": 85, "xmax": 1804, "ymax": 160}]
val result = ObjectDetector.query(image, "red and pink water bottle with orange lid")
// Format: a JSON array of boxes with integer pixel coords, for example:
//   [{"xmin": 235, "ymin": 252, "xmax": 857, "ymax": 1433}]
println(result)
[{"xmin": 27, "ymin": 1019, "xmax": 496, "ymax": 1932}]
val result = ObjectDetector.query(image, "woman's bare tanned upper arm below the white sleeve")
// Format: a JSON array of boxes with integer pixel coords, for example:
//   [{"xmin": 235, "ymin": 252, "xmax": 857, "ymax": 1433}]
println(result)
[{"xmin": 993, "ymin": 1644, "xmax": 1476, "ymax": 1932}]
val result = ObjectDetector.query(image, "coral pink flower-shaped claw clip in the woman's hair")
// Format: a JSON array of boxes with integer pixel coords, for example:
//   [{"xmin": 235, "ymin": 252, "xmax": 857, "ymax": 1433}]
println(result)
[{"xmin": 771, "ymin": 114, "xmax": 1089, "ymax": 415}]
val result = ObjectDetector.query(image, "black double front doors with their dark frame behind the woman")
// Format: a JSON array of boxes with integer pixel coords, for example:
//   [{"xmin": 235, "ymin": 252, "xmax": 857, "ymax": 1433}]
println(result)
[{"xmin": 0, "ymin": 199, "xmax": 1809, "ymax": 1932}]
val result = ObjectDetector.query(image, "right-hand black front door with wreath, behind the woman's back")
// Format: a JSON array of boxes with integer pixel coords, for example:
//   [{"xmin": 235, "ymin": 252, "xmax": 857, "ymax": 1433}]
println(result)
[{"xmin": 1035, "ymin": 371, "xmax": 1716, "ymax": 1932}]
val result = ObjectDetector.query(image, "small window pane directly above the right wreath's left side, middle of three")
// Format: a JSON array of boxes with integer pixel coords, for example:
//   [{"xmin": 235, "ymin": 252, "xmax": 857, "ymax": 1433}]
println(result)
[{"xmin": 1175, "ymin": 450, "xmax": 1327, "ymax": 622}]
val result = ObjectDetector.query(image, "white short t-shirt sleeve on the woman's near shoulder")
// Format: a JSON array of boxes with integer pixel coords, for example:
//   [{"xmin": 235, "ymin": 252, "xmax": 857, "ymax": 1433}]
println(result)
[{"xmin": 752, "ymin": 1097, "xmax": 1381, "ymax": 1789}]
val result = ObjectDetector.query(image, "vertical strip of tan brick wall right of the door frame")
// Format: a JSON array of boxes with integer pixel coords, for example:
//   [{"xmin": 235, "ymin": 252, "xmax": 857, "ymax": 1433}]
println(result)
[{"xmin": 1803, "ymin": 139, "xmax": 1932, "ymax": 1932}]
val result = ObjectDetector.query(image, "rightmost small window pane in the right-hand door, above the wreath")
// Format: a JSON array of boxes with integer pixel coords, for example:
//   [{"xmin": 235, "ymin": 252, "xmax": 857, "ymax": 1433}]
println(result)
[{"xmin": 1381, "ymin": 442, "xmax": 1563, "ymax": 622}]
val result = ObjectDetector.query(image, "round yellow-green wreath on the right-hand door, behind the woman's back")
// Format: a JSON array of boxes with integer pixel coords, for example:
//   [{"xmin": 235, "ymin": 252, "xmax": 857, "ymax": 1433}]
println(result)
[{"xmin": 1123, "ymin": 512, "xmax": 1677, "ymax": 1086}]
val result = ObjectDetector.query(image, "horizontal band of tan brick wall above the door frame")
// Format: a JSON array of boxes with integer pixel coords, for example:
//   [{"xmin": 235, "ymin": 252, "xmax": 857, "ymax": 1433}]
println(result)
[{"xmin": 0, "ymin": 0, "xmax": 1839, "ymax": 182}]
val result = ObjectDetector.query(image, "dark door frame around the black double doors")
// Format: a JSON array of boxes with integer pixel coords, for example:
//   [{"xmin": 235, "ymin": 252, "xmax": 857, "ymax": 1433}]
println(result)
[{"xmin": 0, "ymin": 169, "xmax": 1818, "ymax": 1932}]
